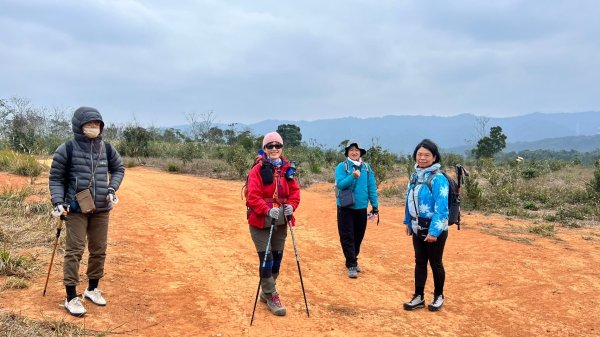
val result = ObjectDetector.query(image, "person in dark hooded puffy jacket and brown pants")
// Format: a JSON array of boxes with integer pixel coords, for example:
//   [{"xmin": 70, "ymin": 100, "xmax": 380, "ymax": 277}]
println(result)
[{"xmin": 50, "ymin": 107, "xmax": 125, "ymax": 316}]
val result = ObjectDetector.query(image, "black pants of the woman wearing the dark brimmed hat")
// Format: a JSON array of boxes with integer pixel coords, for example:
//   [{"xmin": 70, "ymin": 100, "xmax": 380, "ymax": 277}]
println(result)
[{"xmin": 337, "ymin": 207, "xmax": 367, "ymax": 268}]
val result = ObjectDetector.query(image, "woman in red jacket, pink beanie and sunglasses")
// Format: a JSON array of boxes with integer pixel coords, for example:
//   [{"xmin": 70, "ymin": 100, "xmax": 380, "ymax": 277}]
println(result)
[{"xmin": 246, "ymin": 132, "xmax": 300, "ymax": 316}]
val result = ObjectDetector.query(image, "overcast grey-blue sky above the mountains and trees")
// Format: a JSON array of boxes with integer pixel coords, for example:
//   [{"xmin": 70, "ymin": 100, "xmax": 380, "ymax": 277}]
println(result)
[{"xmin": 0, "ymin": 0, "xmax": 600, "ymax": 126}]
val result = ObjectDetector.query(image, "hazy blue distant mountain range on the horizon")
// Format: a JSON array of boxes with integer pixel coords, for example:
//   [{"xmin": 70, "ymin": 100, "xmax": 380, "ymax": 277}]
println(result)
[{"xmin": 247, "ymin": 111, "xmax": 600, "ymax": 154}]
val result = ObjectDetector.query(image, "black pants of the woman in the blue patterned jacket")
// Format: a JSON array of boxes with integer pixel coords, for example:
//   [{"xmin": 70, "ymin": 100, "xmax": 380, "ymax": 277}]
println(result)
[{"xmin": 412, "ymin": 231, "xmax": 448, "ymax": 296}]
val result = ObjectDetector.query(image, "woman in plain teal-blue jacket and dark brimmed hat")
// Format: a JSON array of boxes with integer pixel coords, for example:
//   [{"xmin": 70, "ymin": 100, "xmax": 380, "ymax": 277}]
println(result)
[{"xmin": 335, "ymin": 140, "xmax": 379, "ymax": 278}]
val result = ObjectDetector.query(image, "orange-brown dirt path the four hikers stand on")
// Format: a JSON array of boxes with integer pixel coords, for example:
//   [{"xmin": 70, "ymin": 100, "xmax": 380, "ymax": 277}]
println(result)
[{"xmin": 0, "ymin": 168, "xmax": 600, "ymax": 336}]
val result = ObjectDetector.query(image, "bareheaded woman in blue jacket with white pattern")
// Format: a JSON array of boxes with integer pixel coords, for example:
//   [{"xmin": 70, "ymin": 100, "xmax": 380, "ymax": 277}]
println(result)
[{"xmin": 404, "ymin": 139, "xmax": 450, "ymax": 311}]
